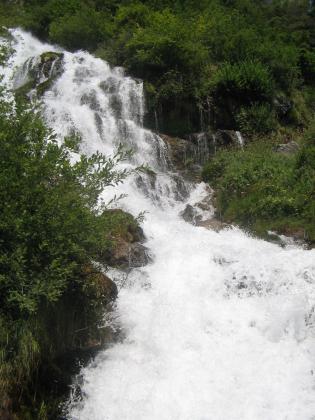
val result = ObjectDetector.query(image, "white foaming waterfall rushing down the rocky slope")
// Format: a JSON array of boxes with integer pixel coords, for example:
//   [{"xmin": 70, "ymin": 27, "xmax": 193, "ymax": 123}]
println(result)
[{"xmin": 2, "ymin": 30, "xmax": 315, "ymax": 420}]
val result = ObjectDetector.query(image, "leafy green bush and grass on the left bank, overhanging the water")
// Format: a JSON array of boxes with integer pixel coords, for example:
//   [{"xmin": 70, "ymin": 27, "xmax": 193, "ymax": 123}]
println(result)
[{"xmin": 0, "ymin": 88, "xmax": 141, "ymax": 419}]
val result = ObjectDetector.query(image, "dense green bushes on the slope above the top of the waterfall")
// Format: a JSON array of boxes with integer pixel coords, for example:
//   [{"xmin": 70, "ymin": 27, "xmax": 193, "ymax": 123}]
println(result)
[{"xmin": 1, "ymin": 0, "xmax": 315, "ymax": 135}]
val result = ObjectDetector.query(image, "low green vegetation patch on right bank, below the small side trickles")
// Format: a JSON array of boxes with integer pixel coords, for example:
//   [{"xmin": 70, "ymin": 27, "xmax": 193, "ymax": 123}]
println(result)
[{"xmin": 203, "ymin": 129, "xmax": 315, "ymax": 244}]
